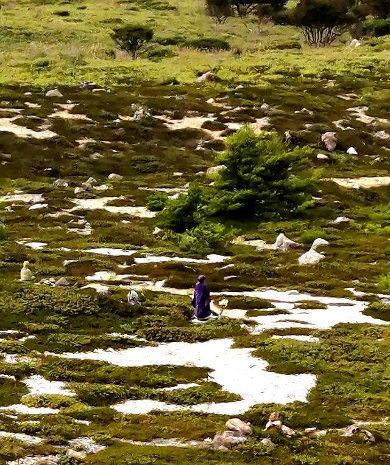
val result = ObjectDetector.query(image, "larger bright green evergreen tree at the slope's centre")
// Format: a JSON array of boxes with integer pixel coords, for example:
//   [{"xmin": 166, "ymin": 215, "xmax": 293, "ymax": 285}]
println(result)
[{"xmin": 205, "ymin": 127, "xmax": 316, "ymax": 218}]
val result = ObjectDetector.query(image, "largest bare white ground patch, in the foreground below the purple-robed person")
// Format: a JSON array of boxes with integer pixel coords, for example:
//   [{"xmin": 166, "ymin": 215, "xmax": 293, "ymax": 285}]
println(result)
[{"xmin": 58, "ymin": 339, "xmax": 316, "ymax": 415}]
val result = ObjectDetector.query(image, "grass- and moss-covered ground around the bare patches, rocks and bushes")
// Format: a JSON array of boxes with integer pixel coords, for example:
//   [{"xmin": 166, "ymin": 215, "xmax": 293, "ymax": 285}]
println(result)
[{"xmin": 0, "ymin": 0, "xmax": 390, "ymax": 465}]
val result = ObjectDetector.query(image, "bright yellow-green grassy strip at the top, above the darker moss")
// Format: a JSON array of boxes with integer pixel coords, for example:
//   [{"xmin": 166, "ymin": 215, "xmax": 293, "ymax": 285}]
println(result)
[{"xmin": 0, "ymin": 0, "xmax": 390, "ymax": 86}]
